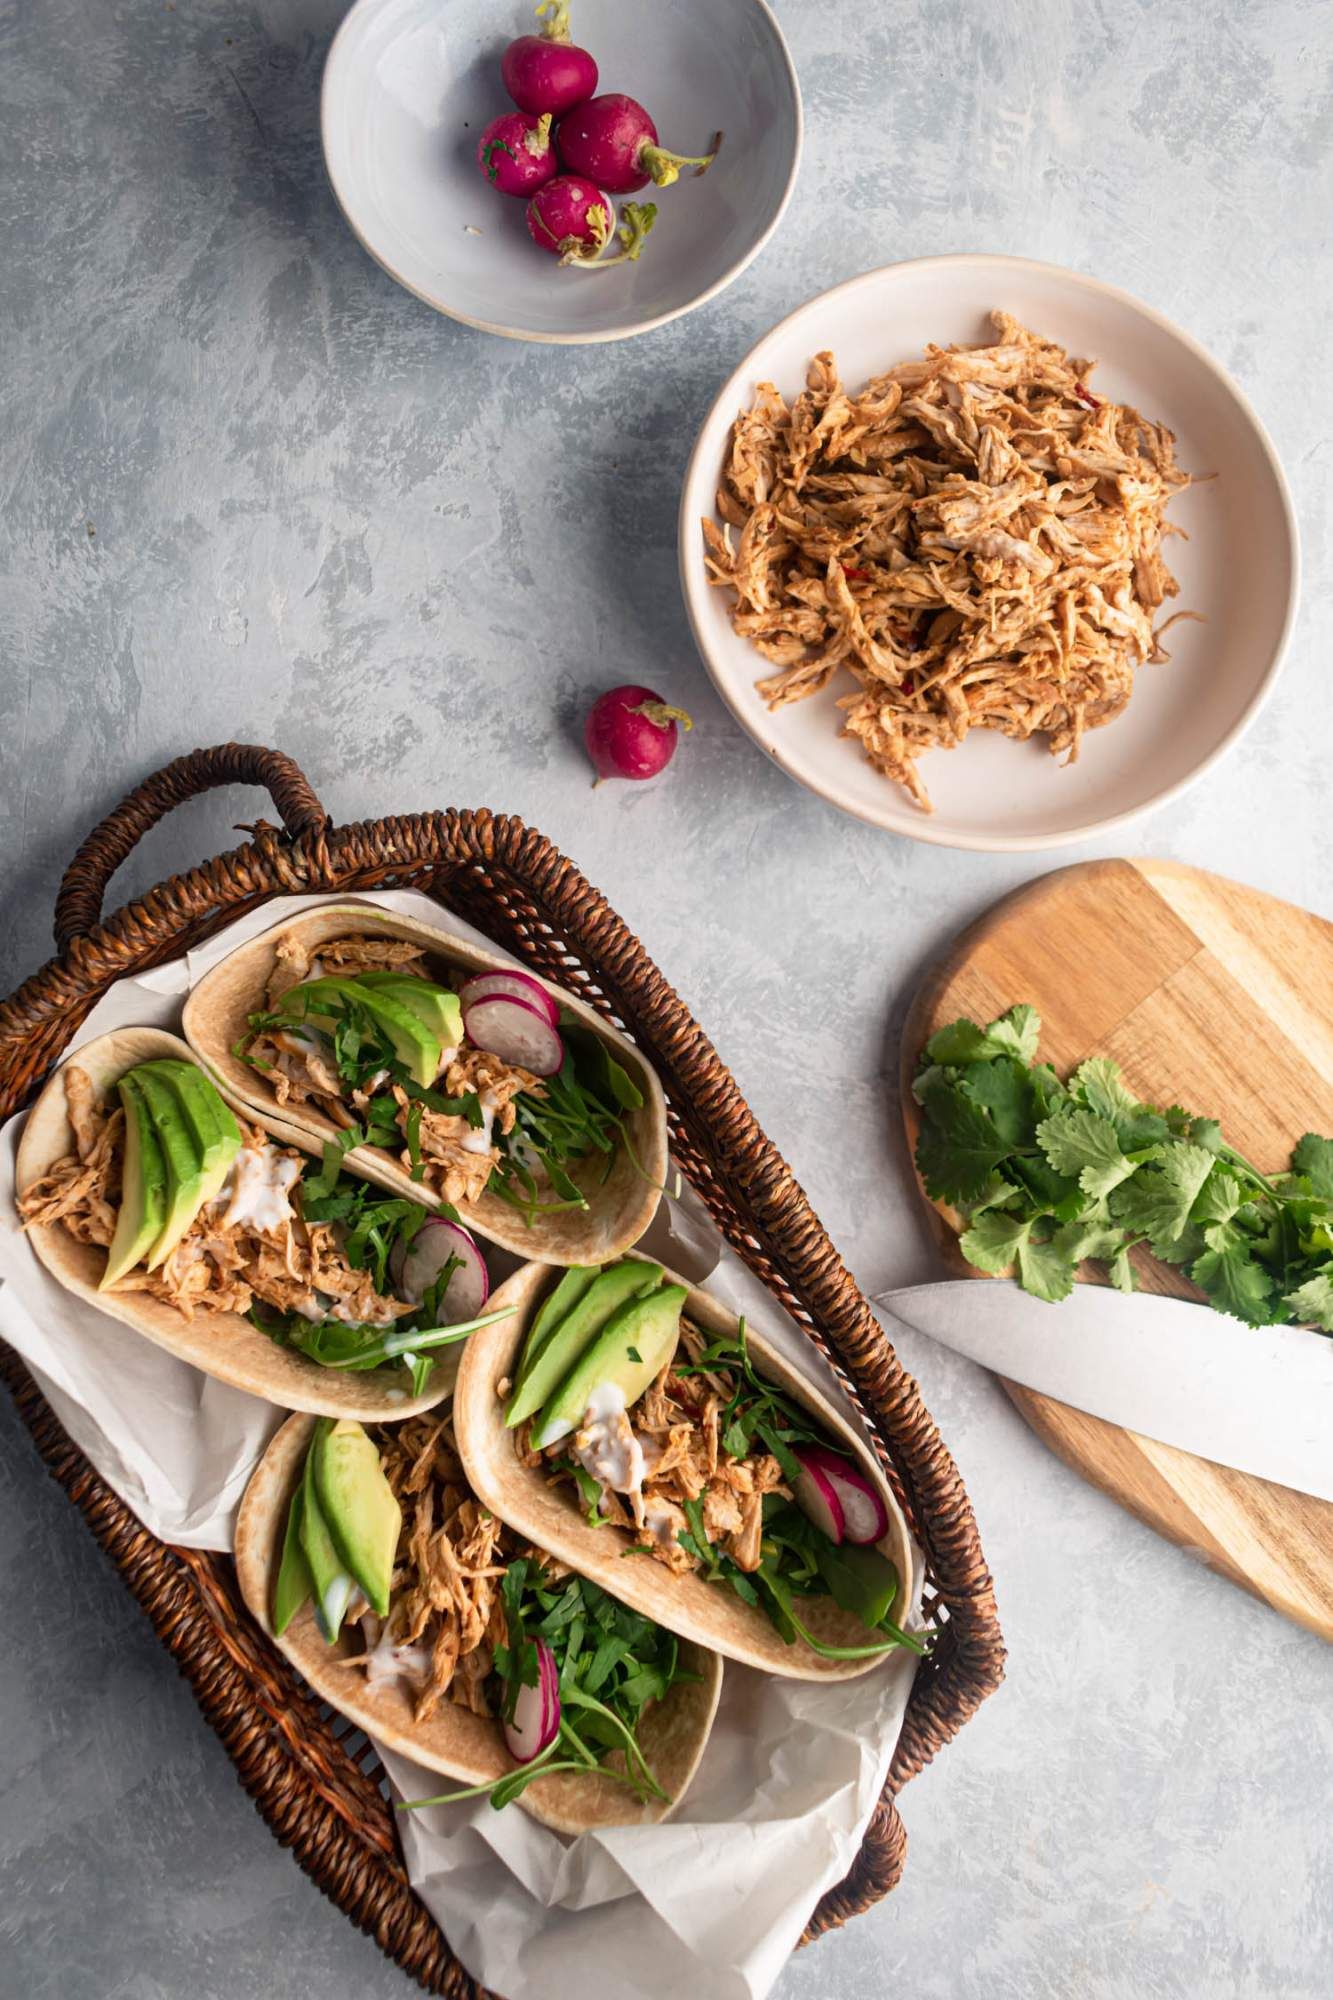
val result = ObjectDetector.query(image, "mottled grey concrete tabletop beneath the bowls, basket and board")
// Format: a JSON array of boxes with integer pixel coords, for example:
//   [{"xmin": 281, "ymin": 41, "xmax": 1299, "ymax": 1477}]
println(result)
[{"xmin": 0, "ymin": 0, "xmax": 1333, "ymax": 2000}]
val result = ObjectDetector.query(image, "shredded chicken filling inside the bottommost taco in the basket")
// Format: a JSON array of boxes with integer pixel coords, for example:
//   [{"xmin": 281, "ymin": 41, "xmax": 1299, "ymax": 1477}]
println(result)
[{"xmin": 344, "ymin": 1410, "xmax": 566, "ymax": 1722}]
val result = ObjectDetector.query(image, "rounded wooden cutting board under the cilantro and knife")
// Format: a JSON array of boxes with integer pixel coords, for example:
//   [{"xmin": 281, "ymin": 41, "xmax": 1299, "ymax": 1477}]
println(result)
[{"xmin": 903, "ymin": 860, "xmax": 1333, "ymax": 1640}]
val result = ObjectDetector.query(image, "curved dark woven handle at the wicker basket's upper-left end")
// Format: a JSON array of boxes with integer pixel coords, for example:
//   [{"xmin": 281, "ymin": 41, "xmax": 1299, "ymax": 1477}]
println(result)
[{"xmin": 56, "ymin": 744, "xmax": 328, "ymax": 952}]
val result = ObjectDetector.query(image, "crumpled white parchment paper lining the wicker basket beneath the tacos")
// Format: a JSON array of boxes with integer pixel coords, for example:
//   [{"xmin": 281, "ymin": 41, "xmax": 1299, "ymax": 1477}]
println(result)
[{"xmin": 0, "ymin": 890, "xmax": 915, "ymax": 2000}]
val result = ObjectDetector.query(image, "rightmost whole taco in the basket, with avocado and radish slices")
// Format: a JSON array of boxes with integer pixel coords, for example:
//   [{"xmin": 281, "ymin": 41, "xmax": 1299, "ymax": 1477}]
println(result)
[{"xmin": 454, "ymin": 1258, "xmax": 925, "ymax": 1680}]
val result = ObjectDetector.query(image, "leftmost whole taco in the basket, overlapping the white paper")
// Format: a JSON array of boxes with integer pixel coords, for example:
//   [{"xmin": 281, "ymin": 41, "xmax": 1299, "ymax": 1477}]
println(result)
[{"xmin": 18, "ymin": 1028, "xmax": 504, "ymax": 1418}]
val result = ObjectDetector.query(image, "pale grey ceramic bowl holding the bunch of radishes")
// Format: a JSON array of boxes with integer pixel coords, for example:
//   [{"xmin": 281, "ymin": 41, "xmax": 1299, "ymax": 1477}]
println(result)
[{"xmin": 320, "ymin": 0, "xmax": 801, "ymax": 342}]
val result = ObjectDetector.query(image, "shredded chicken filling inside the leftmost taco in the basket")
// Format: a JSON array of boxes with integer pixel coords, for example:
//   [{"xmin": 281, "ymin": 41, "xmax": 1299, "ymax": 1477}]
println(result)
[{"xmin": 18, "ymin": 1062, "xmax": 416, "ymax": 1326}]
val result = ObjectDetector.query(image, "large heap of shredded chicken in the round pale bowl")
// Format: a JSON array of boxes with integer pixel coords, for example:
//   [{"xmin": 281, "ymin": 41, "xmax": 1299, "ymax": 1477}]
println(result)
[{"xmin": 703, "ymin": 312, "xmax": 1193, "ymax": 812}]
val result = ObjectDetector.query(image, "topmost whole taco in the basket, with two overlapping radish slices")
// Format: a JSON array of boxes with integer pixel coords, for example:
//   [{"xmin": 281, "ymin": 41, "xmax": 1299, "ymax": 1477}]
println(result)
[{"xmin": 184, "ymin": 904, "xmax": 667, "ymax": 1264}]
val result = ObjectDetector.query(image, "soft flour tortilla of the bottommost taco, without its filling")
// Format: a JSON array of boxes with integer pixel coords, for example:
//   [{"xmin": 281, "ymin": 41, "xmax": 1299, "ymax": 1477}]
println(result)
[{"xmin": 236, "ymin": 1416, "xmax": 723, "ymax": 1834}]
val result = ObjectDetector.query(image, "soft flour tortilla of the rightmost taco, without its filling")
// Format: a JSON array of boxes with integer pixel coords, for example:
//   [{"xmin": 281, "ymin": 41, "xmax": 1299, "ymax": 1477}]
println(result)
[{"xmin": 454, "ymin": 1266, "xmax": 913, "ymax": 1680}]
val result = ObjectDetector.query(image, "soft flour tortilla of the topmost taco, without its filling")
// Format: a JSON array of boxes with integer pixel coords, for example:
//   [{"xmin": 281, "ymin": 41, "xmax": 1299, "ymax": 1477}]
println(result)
[{"xmin": 184, "ymin": 904, "xmax": 667, "ymax": 1264}]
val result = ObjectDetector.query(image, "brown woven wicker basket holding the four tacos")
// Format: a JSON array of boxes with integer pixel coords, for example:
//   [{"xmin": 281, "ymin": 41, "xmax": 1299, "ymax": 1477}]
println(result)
[{"xmin": 0, "ymin": 744, "xmax": 1005, "ymax": 2000}]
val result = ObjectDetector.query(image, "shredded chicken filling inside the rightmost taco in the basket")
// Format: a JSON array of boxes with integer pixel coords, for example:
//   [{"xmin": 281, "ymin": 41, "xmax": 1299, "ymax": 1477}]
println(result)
[{"xmin": 518, "ymin": 1320, "xmax": 791, "ymax": 1570}]
